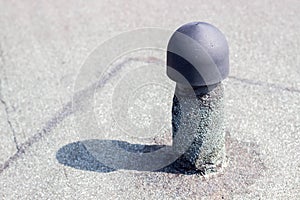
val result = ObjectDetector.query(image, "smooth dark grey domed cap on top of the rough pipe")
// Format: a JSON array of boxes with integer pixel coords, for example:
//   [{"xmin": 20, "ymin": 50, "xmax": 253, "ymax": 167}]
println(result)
[{"xmin": 167, "ymin": 22, "xmax": 229, "ymax": 86}]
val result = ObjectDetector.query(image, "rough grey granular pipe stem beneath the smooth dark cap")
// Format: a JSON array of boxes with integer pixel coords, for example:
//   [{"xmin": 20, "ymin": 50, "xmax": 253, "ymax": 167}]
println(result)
[{"xmin": 172, "ymin": 83, "xmax": 225, "ymax": 174}]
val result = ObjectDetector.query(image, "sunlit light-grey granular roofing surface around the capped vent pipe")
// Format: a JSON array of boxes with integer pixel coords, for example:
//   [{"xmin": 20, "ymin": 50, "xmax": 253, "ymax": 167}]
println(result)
[{"xmin": 0, "ymin": 0, "xmax": 300, "ymax": 200}]
